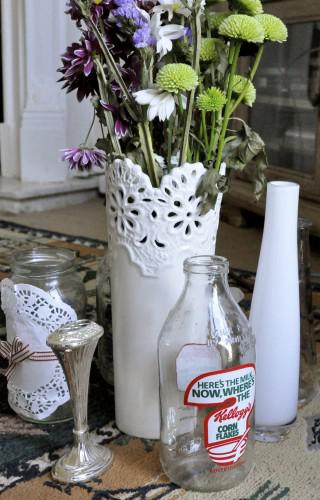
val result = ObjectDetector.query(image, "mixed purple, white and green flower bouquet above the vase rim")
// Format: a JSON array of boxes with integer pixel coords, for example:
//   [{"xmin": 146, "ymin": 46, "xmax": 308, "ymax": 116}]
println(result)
[{"xmin": 59, "ymin": 0, "xmax": 287, "ymax": 204}]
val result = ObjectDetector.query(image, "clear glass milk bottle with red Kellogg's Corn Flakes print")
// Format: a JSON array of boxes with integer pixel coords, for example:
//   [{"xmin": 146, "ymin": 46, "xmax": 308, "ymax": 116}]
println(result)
[{"xmin": 159, "ymin": 256, "xmax": 255, "ymax": 492}]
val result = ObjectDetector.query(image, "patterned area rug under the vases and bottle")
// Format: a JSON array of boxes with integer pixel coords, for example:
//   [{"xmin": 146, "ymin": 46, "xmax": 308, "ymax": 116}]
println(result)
[{"xmin": 0, "ymin": 221, "xmax": 320, "ymax": 500}]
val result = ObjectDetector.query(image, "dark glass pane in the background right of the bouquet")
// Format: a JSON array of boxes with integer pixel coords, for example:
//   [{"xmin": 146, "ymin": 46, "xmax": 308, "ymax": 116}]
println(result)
[{"xmin": 251, "ymin": 23, "xmax": 320, "ymax": 174}]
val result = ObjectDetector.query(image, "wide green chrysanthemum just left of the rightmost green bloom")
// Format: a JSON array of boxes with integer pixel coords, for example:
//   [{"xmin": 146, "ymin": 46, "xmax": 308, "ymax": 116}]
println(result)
[{"xmin": 219, "ymin": 14, "xmax": 264, "ymax": 43}]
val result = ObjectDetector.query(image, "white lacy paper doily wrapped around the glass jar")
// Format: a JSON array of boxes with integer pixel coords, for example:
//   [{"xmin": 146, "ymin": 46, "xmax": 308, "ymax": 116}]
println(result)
[{"xmin": 1, "ymin": 279, "xmax": 77, "ymax": 420}]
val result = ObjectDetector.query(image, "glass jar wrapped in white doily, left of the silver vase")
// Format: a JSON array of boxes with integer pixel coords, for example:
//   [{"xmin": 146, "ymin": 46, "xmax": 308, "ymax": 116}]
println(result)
[{"xmin": 5, "ymin": 248, "xmax": 86, "ymax": 424}]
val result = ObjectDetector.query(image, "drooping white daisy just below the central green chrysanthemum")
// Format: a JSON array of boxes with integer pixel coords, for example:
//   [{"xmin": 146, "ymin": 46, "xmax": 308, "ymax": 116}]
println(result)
[{"xmin": 133, "ymin": 89, "xmax": 176, "ymax": 121}]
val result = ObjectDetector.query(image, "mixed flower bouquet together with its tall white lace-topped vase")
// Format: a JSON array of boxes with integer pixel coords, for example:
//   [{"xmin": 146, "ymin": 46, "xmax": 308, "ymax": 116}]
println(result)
[{"xmin": 59, "ymin": 0, "xmax": 287, "ymax": 438}]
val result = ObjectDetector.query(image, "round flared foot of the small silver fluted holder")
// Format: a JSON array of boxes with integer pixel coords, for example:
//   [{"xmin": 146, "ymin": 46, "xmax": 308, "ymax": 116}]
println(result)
[{"xmin": 51, "ymin": 436, "xmax": 113, "ymax": 483}]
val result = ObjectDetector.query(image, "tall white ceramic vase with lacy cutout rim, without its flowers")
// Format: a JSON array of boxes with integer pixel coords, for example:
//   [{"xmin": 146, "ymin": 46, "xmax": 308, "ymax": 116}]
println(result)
[{"xmin": 106, "ymin": 159, "xmax": 221, "ymax": 439}]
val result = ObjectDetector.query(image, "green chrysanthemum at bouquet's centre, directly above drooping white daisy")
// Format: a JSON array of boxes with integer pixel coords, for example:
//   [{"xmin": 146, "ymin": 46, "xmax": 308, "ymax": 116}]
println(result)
[{"xmin": 157, "ymin": 63, "xmax": 198, "ymax": 94}]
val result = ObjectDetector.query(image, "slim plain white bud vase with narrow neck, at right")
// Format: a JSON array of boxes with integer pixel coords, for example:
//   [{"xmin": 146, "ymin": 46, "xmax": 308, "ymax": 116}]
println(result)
[{"xmin": 250, "ymin": 181, "xmax": 300, "ymax": 442}]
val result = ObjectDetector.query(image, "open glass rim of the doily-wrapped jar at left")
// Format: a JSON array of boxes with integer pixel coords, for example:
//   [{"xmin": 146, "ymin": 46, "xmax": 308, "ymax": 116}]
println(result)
[{"xmin": 11, "ymin": 247, "xmax": 76, "ymax": 278}]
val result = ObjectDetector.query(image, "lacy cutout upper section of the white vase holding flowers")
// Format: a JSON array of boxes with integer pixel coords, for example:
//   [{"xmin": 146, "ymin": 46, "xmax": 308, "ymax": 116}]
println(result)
[{"xmin": 107, "ymin": 159, "xmax": 221, "ymax": 276}]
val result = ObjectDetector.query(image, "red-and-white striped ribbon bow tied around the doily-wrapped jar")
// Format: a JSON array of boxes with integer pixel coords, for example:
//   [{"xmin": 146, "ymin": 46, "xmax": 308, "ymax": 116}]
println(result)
[{"xmin": 0, "ymin": 337, "xmax": 57, "ymax": 380}]
